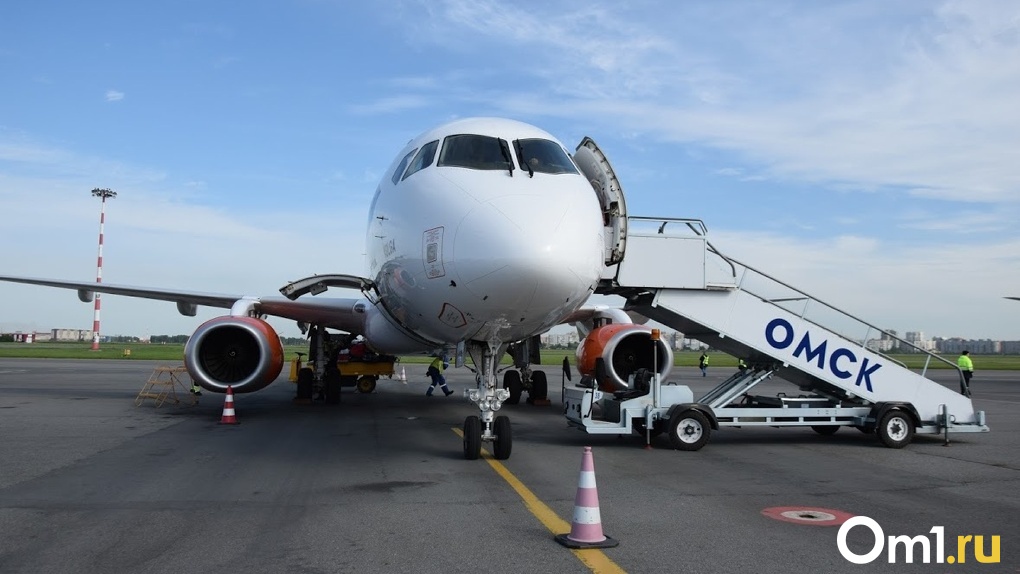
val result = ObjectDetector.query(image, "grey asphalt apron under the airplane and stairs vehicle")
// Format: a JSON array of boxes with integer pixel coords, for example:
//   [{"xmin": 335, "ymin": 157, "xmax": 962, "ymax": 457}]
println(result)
[{"xmin": 0, "ymin": 359, "xmax": 1020, "ymax": 574}]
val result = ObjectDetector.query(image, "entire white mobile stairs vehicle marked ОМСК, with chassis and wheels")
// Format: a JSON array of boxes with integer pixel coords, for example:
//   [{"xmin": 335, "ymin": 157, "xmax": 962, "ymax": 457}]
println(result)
[{"xmin": 565, "ymin": 217, "xmax": 988, "ymax": 451}]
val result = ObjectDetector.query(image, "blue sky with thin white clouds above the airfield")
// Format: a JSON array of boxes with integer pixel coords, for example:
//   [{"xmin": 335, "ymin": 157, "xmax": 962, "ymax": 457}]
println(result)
[{"xmin": 0, "ymin": 0, "xmax": 1020, "ymax": 340}]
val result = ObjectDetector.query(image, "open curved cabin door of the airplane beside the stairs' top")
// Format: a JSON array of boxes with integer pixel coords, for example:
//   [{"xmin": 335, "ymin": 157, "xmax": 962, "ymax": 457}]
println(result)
[{"xmin": 573, "ymin": 137, "xmax": 627, "ymax": 265}]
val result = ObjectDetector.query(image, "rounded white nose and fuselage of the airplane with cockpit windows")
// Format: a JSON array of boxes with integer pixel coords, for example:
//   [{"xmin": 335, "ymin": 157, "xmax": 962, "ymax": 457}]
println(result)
[{"xmin": 366, "ymin": 118, "xmax": 605, "ymax": 345}]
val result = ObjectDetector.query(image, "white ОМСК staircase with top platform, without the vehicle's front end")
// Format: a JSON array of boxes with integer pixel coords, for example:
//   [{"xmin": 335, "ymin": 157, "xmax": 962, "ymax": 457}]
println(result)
[{"xmin": 597, "ymin": 217, "xmax": 988, "ymax": 433}]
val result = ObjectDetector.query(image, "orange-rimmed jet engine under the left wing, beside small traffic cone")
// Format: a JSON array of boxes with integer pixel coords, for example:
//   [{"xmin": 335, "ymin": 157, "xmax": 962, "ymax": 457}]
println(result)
[{"xmin": 185, "ymin": 316, "xmax": 284, "ymax": 393}]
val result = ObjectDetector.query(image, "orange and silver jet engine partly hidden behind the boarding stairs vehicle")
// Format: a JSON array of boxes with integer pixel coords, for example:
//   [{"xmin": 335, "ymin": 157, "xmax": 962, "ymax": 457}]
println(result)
[{"xmin": 577, "ymin": 323, "xmax": 673, "ymax": 393}]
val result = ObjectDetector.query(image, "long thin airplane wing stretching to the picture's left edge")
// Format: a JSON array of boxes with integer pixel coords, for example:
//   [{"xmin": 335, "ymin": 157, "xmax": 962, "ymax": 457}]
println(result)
[{"xmin": 0, "ymin": 275, "xmax": 370, "ymax": 334}]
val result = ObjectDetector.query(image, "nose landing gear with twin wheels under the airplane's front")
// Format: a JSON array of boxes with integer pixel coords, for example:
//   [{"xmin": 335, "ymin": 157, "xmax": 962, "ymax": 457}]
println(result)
[{"xmin": 464, "ymin": 340, "xmax": 513, "ymax": 461}]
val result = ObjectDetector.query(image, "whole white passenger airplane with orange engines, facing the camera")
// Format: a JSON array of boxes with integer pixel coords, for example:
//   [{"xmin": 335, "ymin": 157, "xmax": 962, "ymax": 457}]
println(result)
[{"xmin": 0, "ymin": 118, "xmax": 672, "ymax": 459}]
